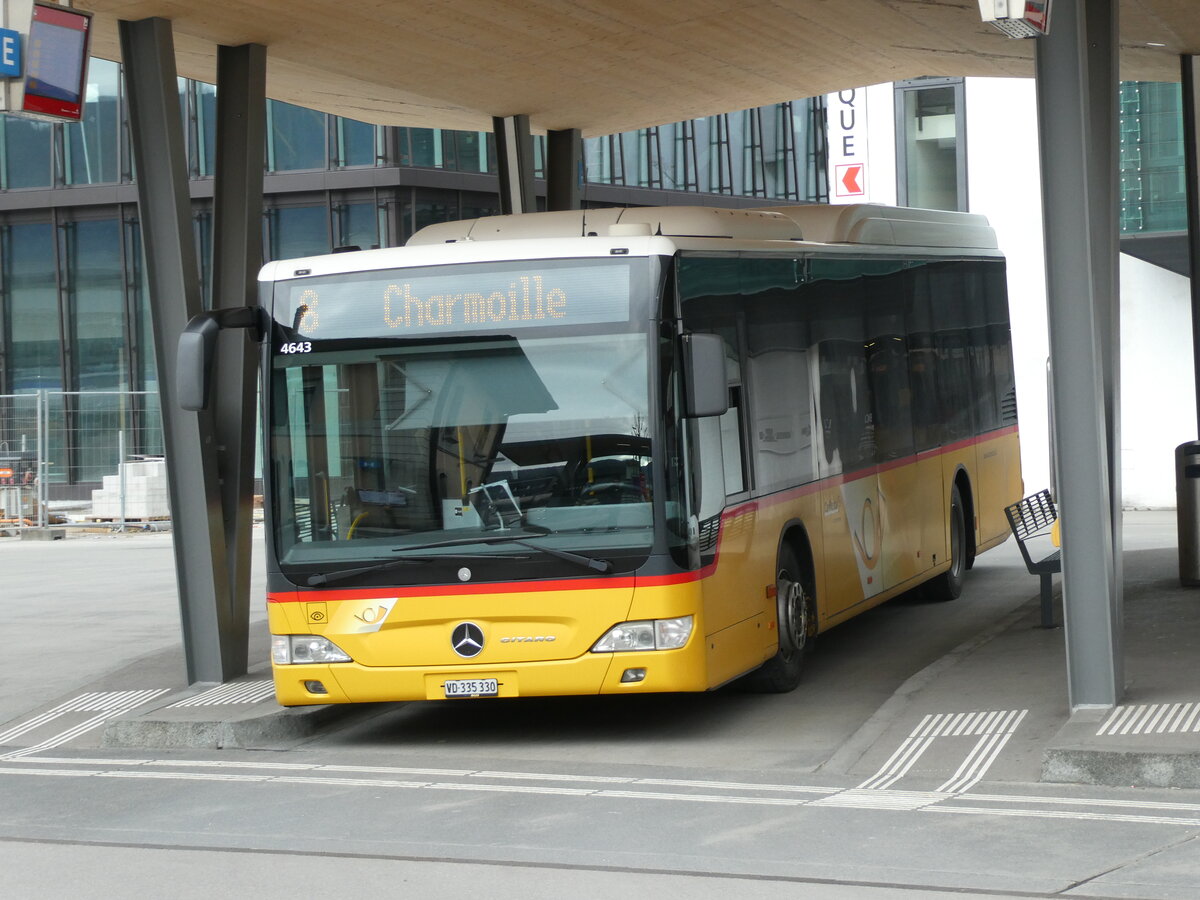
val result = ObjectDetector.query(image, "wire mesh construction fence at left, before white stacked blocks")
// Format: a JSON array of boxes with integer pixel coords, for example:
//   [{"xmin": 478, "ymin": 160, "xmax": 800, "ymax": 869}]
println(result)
[{"xmin": 0, "ymin": 390, "xmax": 169, "ymax": 529}]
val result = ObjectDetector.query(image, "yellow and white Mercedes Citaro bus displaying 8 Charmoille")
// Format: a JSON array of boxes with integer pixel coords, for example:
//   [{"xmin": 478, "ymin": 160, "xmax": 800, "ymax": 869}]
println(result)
[{"xmin": 248, "ymin": 205, "xmax": 1021, "ymax": 706}]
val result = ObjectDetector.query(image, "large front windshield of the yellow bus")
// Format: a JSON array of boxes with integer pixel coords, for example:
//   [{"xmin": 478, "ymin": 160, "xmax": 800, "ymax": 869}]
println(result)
[{"xmin": 269, "ymin": 259, "xmax": 653, "ymax": 580}]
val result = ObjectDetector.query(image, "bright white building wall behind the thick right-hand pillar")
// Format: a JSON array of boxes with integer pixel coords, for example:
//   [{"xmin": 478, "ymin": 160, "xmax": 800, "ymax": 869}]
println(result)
[{"xmin": 966, "ymin": 78, "xmax": 1196, "ymax": 509}]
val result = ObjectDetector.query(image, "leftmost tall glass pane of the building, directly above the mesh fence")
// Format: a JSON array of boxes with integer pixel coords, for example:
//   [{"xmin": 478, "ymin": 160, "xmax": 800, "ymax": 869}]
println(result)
[{"xmin": 2, "ymin": 223, "xmax": 62, "ymax": 394}]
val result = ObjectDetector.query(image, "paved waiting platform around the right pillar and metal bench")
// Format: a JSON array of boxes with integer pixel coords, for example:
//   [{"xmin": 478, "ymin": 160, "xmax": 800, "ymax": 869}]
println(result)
[{"xmin": 835, "ymin": 511, "xmax": 1200, "ymax": 788}]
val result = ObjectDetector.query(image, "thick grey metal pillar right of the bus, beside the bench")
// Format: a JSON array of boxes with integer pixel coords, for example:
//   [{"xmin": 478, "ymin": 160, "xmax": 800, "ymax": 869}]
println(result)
[{"xmin": 1036, "ymin": 0, "xmax": 1124, "ymax": 709}]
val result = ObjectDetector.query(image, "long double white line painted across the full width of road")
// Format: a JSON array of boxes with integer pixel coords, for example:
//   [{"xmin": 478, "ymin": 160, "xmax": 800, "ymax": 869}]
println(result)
[{"xmin": 0, "ymin": 758, "xmax": 1200, "ymax": 828}]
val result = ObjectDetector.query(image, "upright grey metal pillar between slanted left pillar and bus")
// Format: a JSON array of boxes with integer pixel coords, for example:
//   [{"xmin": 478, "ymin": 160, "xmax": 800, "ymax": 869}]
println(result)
[{"xmin": 212, "ymin": 44, "xmax": 266, "ymax": 680}]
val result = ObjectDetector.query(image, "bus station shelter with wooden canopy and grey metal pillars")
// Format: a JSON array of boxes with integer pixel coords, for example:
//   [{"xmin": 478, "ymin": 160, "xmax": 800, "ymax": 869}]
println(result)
[{"xmin": 25, "ymin": 0, "xmax": 1200, "ymax": 709}]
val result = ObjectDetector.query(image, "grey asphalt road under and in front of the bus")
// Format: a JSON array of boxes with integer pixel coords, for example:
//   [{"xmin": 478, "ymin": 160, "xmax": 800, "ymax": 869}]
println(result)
[{"xmin": 0, "ymin": 518, "xmax": 1200, "ymax": 900}]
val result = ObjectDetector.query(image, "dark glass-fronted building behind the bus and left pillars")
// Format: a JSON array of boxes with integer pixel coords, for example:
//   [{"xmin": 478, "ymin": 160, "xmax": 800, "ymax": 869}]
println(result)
[{"xmin": 0, "ymin": 59, "xmax": 827, "ymax": 496}]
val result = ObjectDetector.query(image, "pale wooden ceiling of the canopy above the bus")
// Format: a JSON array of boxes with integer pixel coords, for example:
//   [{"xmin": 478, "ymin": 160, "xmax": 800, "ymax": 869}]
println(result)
[{"xmin": 87, "ymin": 0, "xmax": 1200, "ymax": 136}]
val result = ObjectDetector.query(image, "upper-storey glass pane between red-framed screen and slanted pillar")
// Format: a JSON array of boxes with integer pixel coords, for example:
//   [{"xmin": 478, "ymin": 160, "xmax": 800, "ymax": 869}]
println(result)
[{"xmin": 62, "ymin": 59, "xmax": 121, "ymax": 185}]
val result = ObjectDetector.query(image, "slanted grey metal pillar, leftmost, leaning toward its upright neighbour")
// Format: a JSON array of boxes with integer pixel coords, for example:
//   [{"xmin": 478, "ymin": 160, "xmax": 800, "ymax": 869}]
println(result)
[{"xmin": 120, "ymin": 18, "xmax": 229, "ymax": 683}]
